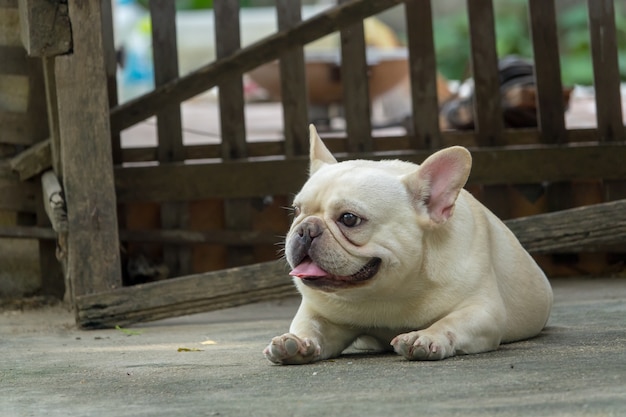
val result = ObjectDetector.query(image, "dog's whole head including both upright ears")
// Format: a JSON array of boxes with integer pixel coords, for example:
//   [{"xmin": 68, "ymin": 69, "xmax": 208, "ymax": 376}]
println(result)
[{"xmin": 285, "ymin": 128, "xmax": 471, "ymax": 291}]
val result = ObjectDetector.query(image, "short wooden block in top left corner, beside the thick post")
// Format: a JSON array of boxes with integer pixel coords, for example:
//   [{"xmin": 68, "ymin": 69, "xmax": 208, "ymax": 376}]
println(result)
[{"xmin": 18, "ymin": 0, "xmax": 72, "ymax": 57}]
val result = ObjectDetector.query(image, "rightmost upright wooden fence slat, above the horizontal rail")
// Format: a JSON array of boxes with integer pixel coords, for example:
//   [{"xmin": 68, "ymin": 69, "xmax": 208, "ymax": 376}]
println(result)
[{"xmin": 587, "ymin": 0, "xmax": 626, "ymax": 141}]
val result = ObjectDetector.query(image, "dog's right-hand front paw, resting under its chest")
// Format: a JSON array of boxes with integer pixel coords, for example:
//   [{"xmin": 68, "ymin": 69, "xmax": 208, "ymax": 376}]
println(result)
[{"xmin": 391, "ymin": 331, "xmax": 455, "ymax": 361}]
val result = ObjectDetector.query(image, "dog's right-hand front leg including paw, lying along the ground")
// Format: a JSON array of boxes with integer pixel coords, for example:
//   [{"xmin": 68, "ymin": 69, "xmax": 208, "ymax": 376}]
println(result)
[{"xmin": 391, "ymin": 307, "xmax": 502, "ymax": 360}]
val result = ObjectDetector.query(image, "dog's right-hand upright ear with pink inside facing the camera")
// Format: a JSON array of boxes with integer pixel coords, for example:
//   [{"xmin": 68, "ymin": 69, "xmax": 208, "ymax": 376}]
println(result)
[{"xmin": 404, "ymin": 146, "xmax": 472, "ymax": 223}]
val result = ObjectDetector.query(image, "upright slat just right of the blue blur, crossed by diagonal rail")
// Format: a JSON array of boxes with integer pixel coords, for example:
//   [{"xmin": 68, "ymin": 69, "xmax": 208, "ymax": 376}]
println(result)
[{"xmin": 150, "ymin": 0, "xmax": 191, "ymax": 276}]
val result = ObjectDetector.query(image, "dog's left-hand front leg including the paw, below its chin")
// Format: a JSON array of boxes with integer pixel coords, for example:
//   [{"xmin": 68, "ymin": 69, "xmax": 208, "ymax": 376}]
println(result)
[{"xmin": 263, "ymin": 308, "xmax": 360, "ymax": 365}]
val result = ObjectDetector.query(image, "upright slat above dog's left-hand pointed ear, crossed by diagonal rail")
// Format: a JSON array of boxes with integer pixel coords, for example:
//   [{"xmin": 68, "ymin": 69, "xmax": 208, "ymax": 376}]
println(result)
[{"xmin": 276, "ymin": 0, "xmax": 309, "ymax": 156}]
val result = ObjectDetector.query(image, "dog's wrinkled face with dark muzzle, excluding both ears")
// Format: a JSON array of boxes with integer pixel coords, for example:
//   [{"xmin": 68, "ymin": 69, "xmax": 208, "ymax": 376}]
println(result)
[{"xmin": 285, "ymin": 161, "xmax": 408, "ymax": 290}]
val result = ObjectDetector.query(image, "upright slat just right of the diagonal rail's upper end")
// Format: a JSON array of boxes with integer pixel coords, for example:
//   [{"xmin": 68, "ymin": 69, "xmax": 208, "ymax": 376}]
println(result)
[{"xmin": 405, "ymin": 0, "xmax": 441, "ymax": 149}]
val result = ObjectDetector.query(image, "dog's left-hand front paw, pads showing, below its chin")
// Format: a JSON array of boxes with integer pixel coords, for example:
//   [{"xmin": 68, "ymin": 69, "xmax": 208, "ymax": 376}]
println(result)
[{"xmin": 263, "ymin": 333, "xmax": 321, "ymax": 365}]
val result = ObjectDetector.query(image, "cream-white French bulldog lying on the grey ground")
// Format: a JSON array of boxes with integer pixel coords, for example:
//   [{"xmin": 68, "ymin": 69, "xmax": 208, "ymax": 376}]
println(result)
[{"xmin": 264, "ymin": 125, "xmax": 552, "ymax": 364}]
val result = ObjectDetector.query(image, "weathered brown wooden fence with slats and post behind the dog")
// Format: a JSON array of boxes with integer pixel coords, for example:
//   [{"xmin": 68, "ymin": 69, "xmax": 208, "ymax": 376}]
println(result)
[{"xmin": 5, "ymin": 0, "xmax": 626, "ymax": 328}]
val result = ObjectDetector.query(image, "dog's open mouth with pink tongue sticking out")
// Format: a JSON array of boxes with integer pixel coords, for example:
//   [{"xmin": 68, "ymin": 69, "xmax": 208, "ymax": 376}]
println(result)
[{"xmin": 289, "ymin": 256, "xmax": 381, "ymax": 289}]
